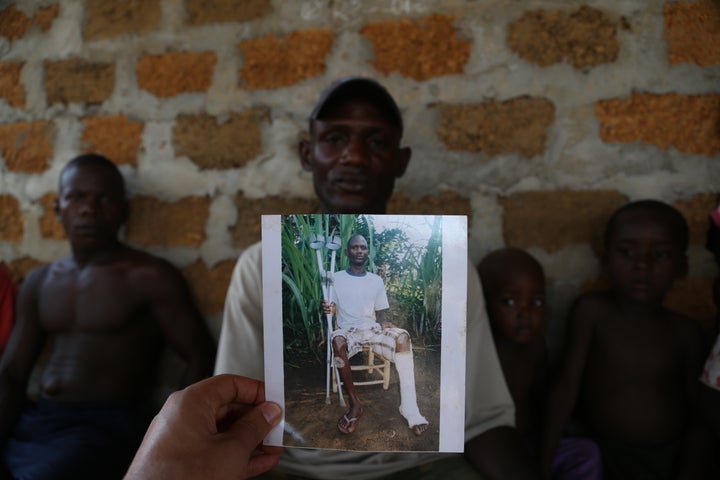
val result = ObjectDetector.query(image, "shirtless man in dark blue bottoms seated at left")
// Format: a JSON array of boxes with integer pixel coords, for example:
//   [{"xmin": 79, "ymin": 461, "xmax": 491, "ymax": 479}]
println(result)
[{"xmin": 0, "ymin": 155, "xmax": 214, "ymax": 479}]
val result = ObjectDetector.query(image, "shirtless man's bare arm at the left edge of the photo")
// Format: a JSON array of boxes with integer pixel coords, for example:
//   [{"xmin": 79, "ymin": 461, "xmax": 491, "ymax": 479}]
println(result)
[{"xmin": 0, "ymin": 266, "xmax": 49, "ymax": 440}]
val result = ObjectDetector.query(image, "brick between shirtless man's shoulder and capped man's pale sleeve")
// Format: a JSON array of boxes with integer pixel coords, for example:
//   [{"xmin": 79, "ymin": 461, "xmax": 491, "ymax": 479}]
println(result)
[{"xmin": 182, "ymin": 259, "xmax": 235, "ymax": 317}]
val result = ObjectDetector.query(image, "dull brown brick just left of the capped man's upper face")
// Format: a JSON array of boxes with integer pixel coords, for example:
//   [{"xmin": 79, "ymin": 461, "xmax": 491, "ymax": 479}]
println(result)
[{"xmin": 173, "ymin": 109, "xmax": 269, "ymax": 169}]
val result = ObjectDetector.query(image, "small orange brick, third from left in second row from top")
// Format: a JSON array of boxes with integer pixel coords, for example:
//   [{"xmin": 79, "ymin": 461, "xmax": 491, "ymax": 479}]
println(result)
[{"xmin": 135, "ymin": 52, "xmax": 217, "ymax": 97}]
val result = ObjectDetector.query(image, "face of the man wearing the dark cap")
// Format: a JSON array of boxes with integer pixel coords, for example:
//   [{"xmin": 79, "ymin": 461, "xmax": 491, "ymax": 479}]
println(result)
[{"xmin": 299, "ymin": 100, "xmax": 410, "ymax": 213}]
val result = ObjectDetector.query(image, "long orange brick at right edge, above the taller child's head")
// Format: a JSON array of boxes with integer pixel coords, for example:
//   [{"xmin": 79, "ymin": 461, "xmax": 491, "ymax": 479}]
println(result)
[{"xmin": 595, "ymin": 93, "xmax": 720, "ymax": 156}]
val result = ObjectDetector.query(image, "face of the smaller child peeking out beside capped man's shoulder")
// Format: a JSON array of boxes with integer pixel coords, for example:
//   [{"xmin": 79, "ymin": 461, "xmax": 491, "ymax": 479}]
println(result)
[{"xmin": 487, "ymin": 269, "xmax": 545, "ymax": 344}]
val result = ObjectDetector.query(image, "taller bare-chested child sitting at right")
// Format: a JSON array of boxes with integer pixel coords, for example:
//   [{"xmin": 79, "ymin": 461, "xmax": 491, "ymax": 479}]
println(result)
[{"xmin": 542, "ymin": 200, "xmax": 703, "ymax": 480}]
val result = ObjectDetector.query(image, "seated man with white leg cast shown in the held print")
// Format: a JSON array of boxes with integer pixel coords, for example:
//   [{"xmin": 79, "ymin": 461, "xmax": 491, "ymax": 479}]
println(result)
[{"xmin": 323, "ymin": 235, "xmax": 428, "ymax": 436}]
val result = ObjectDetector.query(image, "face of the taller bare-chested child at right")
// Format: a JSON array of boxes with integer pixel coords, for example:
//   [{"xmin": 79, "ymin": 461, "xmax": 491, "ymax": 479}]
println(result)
[{"xmin": 605, "ymin": 209, "xmax": 687, "ymax": 304}]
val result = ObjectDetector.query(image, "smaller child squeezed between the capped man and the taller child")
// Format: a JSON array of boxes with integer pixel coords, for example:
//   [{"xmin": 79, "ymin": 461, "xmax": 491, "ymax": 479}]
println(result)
[{"xmin": 478, "ymin": 248, "xmax": 602, "ymax": 480}]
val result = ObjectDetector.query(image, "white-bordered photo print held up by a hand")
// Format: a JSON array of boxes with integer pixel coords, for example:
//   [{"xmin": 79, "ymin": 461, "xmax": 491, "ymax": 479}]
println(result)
[{"xmin": 262, "ymin": 214, "xmax": 468, "ymax": 452}]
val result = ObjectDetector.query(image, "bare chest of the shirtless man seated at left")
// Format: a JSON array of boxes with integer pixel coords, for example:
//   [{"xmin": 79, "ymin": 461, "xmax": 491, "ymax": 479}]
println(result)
[{"xmin": 38, "ymin": 267, "xmax": 142, "ymax": 332}]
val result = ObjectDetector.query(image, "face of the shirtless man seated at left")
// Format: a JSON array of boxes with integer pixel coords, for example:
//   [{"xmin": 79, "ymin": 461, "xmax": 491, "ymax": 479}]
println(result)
[{"xmin": 55, "ymin": 165, "xmax": 127, "ymax": 249}]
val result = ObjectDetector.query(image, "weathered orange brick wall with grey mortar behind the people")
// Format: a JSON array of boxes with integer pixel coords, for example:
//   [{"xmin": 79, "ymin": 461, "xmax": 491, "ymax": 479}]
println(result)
[{"xmin": 0, "ymin": 0, "xmax": 720, "ymax": 348}]
